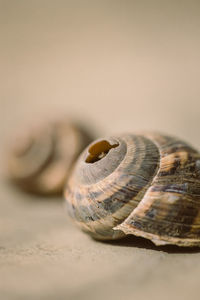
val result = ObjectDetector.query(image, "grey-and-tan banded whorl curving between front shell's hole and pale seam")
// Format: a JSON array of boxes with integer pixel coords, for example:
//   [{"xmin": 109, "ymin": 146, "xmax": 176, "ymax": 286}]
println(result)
[{"xmin": 65, "ymin": 135, "xmax": 159, "ymax": 239}]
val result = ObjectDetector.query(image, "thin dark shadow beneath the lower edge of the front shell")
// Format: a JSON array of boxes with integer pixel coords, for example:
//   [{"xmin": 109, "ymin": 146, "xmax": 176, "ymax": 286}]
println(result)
[{"xmin": 98, "ymin": 235, "xmax": 200, "ymax": 254}]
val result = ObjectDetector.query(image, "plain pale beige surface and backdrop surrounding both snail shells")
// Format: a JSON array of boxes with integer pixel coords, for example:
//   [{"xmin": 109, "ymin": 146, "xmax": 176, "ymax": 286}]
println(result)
[{"xmin": 0, "ymin": 0, "xmax": 200, "ymax": 300}]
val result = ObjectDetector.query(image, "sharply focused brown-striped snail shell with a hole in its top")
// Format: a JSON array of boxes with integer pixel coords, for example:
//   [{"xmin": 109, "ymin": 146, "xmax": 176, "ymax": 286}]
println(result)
[{"xmin": 65, "ymin": 133, "xmax": 200, "ymax": 246}]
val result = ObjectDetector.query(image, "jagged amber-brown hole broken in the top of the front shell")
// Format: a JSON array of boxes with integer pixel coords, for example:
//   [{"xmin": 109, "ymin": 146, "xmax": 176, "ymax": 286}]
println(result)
[{"xmin": 85, "ymin": 140, "xmax": 119, "ymax": 164}]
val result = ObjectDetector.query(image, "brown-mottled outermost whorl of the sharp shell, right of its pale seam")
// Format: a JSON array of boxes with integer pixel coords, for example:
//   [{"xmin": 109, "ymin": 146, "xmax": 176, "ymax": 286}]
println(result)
[{"xmin": 116, "ymin": 135, "xmax": 200, "ymax": 246}]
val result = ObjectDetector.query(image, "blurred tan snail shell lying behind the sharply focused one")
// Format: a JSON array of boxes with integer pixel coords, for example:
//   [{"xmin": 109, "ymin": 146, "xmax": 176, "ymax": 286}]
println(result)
[{"xmin": 8, "ymin": 120, "xmax": 91, "ymax": 195}]
